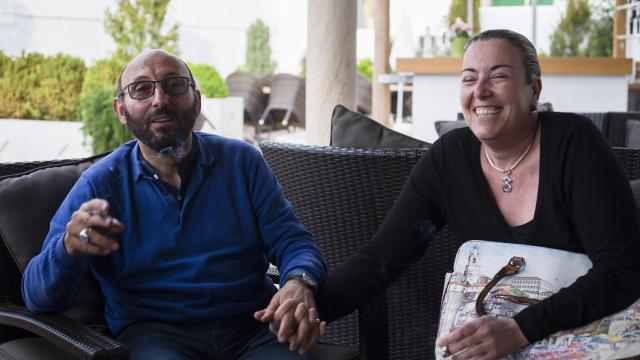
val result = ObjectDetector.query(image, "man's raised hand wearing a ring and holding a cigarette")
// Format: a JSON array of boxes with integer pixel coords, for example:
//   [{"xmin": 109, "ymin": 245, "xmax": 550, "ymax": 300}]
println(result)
[{"xmin": 64, "ymin": 199, "xmax": 124, "ymax": 256}]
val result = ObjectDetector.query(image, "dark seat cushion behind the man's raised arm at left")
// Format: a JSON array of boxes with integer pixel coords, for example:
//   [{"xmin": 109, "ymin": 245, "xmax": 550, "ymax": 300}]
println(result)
[{"xmin": 0, "ymin": 154, "xmax": 104, "ymax": 323}]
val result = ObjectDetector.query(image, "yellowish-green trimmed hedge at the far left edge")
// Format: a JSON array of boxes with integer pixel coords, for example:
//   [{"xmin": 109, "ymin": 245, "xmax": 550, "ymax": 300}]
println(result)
[{"xmin": 0, "ymin": 51, "xmax": 86, "ymax": 120}]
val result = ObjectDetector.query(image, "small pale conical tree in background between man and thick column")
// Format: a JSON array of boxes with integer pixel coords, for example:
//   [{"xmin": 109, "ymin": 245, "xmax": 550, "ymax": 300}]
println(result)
[{"xmin": 245, "ymin": 19, "xmax": 276, "ymax": 76}]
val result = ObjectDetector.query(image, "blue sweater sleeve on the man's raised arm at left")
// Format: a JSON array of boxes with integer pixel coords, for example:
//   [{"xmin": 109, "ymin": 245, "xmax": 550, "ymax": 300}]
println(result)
[{"xmin": 22, "ymin": 176, "xmax": 94, "ymax": 313}]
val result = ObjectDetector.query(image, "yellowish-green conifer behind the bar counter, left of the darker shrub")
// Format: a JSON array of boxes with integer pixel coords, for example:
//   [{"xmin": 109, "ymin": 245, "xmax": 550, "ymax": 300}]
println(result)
[{"xmin": 551, "ymin": 0, "xmax": 591, "ymax": 56}]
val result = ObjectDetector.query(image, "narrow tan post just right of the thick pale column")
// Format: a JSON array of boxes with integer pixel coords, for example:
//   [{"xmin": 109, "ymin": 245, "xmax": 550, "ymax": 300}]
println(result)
[{"xmin": 372, "ymin": 0, "xmax": 391, "ymax": 127}]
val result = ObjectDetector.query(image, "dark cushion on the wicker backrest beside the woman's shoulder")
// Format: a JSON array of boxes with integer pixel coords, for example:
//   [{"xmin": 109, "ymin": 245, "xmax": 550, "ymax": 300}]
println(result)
[{"xmin": 330, "ymin": 105, "xmax": 431, "ymax": 148}]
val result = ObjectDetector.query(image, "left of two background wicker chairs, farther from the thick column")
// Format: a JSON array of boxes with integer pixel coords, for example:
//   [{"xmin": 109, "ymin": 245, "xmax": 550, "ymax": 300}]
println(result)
[{"xmin": 226, "ymin": 72, "xmax": 267, "ymax": 126}]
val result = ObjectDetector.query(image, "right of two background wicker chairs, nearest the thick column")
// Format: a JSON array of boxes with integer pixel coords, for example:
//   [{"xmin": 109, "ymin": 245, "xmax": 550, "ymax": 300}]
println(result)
[{"xmin": 258, "ymin": 74, "xmax": 305, "ymax": 129}]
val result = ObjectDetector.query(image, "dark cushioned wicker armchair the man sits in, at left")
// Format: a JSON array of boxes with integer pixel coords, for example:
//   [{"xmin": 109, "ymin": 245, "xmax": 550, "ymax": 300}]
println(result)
[{"xmin": 0, "ymin": 154, "xmax": 357, "ymax": 360}]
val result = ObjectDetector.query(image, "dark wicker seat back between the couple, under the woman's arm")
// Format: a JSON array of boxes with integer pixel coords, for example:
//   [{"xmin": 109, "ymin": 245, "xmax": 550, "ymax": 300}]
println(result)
[{"xmin": 260, "ymin": 141, "xmax": 640, "ymax": 359}]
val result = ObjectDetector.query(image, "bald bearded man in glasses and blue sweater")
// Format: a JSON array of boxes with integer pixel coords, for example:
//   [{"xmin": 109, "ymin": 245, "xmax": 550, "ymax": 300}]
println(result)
[{"xmin": 22, "ymin": 50, "xmax": 326, "ymax": 360}]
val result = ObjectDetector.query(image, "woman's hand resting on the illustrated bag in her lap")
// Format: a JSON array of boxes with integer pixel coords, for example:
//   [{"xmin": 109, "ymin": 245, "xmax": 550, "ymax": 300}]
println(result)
[{"xmin": 437, "ymin": 315, "xmax": 529, "ymax": 360}]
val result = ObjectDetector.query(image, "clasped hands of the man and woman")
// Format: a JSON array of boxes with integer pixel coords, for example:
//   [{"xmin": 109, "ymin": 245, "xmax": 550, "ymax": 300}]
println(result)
[{"xmin": 254, "ymin": 278, "xmax": 327, "ymax": 355}]
